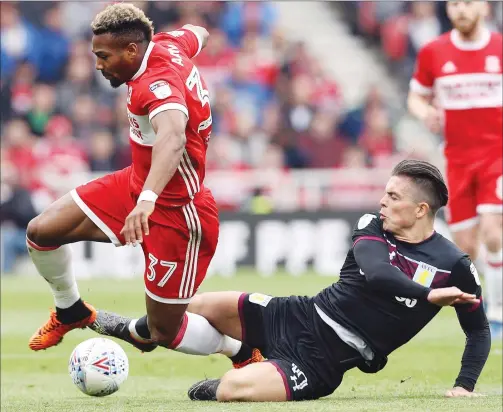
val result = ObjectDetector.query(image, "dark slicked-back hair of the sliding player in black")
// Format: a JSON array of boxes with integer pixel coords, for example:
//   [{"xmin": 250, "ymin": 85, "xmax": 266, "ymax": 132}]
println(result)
[{"xmin": 391, "ymin": 159, "xmax": 449, "ymax": 216}]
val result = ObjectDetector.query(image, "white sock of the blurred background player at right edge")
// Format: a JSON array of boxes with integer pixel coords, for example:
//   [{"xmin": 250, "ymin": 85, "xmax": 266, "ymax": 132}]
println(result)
[{"xmin": 484, "ymin": 250, "xmax": 503, "ymax": 322}]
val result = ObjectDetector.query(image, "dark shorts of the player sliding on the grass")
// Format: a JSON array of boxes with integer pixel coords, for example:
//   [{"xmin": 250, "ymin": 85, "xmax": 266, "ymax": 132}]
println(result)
[{"xmin": 239, "ymin": 293, "xmax": 362, "ymax": 401}]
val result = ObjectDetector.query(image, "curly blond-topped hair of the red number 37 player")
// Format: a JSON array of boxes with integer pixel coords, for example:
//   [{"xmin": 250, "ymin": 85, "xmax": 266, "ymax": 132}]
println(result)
[{"xmin": 91, "ymin": 3, "xmax": 154, "ymax": 43}]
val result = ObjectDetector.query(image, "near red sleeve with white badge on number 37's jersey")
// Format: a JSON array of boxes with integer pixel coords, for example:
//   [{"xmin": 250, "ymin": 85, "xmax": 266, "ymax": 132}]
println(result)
[{"xmin": 135, "ymin": 71, "xmax": 189, "ymax": 120}]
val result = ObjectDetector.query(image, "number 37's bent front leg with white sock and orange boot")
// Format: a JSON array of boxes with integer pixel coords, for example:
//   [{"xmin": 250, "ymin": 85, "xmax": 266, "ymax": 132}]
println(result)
[{"xmin": 26, "ymin": 194, "xmax": 110, "ymax": 350}]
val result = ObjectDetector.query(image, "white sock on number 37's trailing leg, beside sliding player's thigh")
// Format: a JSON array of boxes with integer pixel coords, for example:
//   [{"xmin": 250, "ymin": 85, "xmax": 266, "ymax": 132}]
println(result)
[{"xmin": 170, "ymin": 312, "xmax": 241, "ymax": 357}]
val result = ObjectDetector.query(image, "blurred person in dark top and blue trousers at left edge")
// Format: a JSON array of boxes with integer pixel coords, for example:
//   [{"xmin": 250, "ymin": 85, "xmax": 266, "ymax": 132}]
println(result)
[{"xmin": 0, "ymin": 151, "xmax": 37, "ymax": 274}]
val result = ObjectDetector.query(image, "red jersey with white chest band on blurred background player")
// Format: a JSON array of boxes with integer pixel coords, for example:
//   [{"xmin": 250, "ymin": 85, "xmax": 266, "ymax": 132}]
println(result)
[{"xmin": 410, "ymin": 30, "xmax": 503, "ymax": 162}]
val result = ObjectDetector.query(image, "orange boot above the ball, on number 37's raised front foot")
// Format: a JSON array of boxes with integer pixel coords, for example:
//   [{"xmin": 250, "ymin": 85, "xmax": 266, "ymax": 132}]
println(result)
[{"xmin": 29, "ymin": 302, "xmax": 97, "ymax": 351}]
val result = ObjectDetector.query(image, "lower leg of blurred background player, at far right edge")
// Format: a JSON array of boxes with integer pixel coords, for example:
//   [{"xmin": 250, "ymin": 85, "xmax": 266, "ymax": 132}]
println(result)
[{"xmin": 480, "ymin": 213, "xmax": 503, "ymax": 337}]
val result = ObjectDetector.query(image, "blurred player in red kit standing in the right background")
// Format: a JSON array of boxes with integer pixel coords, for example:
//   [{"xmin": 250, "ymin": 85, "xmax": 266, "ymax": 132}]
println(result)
[{"xmin": 408, "ymin": 1, "xmax": 503, "ymax": 334}]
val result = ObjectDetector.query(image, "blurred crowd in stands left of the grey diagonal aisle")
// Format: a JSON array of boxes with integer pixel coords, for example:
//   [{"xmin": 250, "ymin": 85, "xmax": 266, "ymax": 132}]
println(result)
[{"xmin": 0, "ymin": 1, "xmax": 404, "ymax": 274}]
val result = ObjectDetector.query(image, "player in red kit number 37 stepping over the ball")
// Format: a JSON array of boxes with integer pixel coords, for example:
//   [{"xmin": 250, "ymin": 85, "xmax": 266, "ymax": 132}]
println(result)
[{"xmin": 23, "ymin": 3, "xmax": 260, "ymax": 361}]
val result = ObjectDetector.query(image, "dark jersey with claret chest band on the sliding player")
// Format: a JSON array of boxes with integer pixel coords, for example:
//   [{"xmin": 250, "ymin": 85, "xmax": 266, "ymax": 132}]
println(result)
[{"xmin": 315, "ymin": 214, "xmax": 481, "ymax": 355}]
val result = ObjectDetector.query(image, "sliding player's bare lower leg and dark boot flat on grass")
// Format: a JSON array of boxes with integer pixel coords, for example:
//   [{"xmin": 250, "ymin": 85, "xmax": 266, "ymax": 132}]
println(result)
[{"xmin": 188, "ymin": 362, "xmax": 290, "ymax": 402}]
